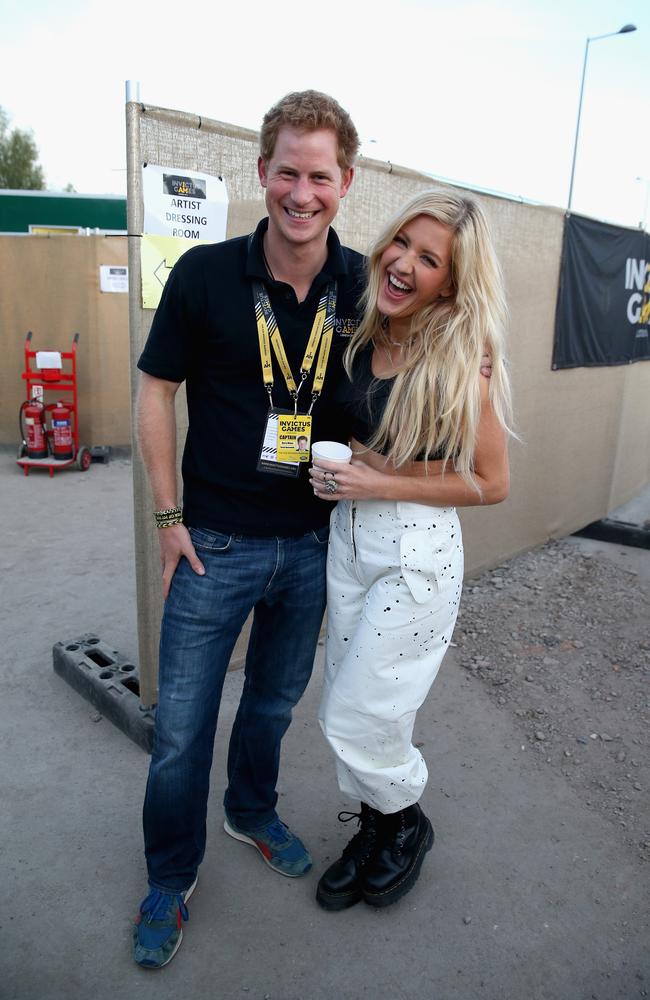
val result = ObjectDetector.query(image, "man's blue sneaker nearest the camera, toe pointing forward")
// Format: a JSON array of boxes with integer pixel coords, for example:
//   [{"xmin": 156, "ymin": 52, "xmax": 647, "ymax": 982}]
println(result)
[{"xmin": 133, "ymin": 879, "xmax": 197, "ymax": 969}]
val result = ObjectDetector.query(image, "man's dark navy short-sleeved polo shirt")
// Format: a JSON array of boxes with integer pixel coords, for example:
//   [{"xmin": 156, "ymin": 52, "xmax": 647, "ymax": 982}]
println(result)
[{"xmin": 138, "ymin": 219, "xmax": 364, "ymax": 535}]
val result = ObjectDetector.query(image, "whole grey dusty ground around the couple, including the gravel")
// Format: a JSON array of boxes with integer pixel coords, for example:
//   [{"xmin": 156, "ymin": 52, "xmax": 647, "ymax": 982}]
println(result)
[{"xmin": 0, "ymin": 458, "xmax": 650, "ymax": 1000}]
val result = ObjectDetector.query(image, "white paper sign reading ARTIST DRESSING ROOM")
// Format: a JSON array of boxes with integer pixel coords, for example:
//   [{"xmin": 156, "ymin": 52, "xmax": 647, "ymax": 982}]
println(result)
[{"xmin": 142, "ymin": 163, "xmax": 228, "ymax": 243}]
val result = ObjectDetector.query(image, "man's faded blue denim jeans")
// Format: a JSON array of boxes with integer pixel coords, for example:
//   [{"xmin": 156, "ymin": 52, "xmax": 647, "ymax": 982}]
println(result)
[{"xmin": 143, "ymin": 527, "xmax": 329, "ymax": 891}]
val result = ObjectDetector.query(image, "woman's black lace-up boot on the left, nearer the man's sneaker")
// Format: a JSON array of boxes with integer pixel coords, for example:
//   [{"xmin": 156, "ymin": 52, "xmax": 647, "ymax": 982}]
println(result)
[{"xmin": 316, "ymin": 802, "xmax": 381, "ymax": 910}]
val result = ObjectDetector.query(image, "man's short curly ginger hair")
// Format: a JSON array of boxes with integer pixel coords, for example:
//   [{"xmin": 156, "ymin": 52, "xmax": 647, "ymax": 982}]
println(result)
[{"xmin": 260, "ymin": 90, "xmax": 359, "ymax": 170}]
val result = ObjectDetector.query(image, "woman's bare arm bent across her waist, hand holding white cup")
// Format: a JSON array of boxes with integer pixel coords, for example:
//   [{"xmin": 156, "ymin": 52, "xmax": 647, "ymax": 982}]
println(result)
[{"xmin": 310, "ymin": 377, "xmax": 510, "ymax": 507}]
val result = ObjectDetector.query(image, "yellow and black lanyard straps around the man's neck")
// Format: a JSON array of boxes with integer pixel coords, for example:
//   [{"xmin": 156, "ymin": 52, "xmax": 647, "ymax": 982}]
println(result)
[{"xmin": 253, "ymin": 281, "xmax": 337, "ymax": 413}]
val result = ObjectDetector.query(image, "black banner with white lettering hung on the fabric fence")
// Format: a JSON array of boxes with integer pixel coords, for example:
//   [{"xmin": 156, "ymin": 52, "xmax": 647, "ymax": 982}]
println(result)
[{"xmin": 552, "ymin": 215, "xmax": 650, "ymax": 369}]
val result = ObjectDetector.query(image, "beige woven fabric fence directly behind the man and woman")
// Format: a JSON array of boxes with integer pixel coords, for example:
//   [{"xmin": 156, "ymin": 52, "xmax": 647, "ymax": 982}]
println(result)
[{"xmin": 120, "ymin": 104, "xmax": 636, "ymax": 701}]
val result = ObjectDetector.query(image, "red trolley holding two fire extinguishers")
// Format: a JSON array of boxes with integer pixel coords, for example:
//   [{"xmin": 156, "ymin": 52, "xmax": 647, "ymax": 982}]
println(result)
[{"xmin": 17, "ymin": 330, "xmax": 92, "ymax": 476}]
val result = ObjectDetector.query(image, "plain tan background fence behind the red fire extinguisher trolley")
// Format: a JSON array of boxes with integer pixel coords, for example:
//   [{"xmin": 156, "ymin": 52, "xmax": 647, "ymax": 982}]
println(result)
[{"xmin": 0, "ymin": 236, "xmax": 131, "ymax": 449}]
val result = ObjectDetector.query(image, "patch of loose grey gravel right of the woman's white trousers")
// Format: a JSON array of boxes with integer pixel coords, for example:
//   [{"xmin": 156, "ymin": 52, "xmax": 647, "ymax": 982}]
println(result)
[{"xmin": 454, "ymin": 540, "xmax": 650, "ymax": 873}]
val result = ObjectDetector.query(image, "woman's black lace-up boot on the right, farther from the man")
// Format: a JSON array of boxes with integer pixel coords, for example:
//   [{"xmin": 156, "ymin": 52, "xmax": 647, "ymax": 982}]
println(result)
[{"xmin": 362, "ymin": 803, "xmax": 433, "ymax": 906}]
